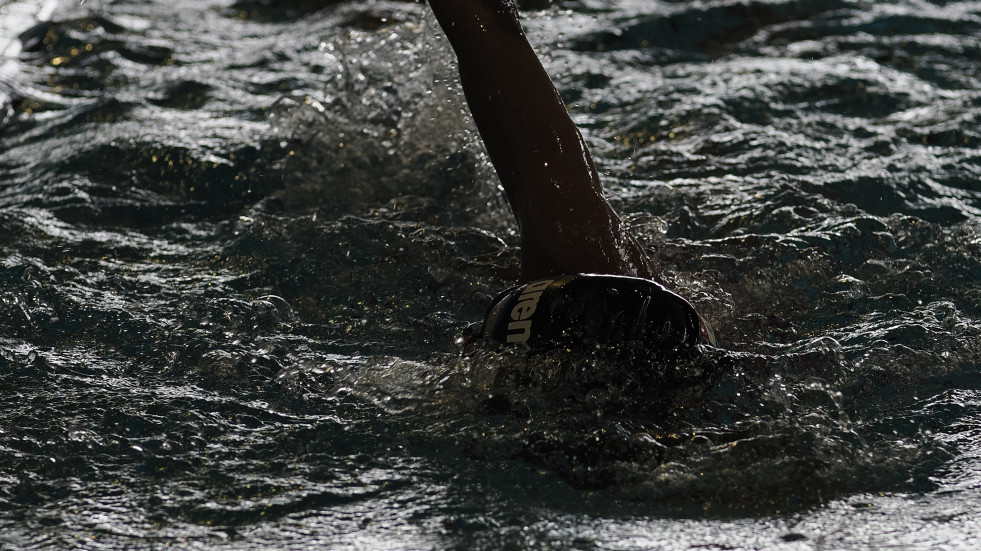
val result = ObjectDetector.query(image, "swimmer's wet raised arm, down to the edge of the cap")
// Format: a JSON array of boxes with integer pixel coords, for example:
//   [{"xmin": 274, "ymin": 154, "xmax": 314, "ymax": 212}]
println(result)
[{"xmin": 429, "ymin": 0, "xmax": 656, "ymax": 279}]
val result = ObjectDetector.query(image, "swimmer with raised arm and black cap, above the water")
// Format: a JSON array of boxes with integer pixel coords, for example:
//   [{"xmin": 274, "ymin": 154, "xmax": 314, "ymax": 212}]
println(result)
[{"xmin": 429, "ymin": 0, "xmax": 715, "ymax": 352}]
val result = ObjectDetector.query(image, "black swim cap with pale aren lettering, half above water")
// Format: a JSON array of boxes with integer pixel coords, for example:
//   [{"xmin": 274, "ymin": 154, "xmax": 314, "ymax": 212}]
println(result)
[{"xmin": 483, "ymin": 274, "xmax": 710, "ymax": 353}]
